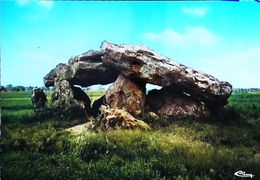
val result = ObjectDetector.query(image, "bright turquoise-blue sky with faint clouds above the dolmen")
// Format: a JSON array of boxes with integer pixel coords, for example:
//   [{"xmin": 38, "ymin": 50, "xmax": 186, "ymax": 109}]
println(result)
[{"xmin": 0, "ymin": 0, "xmax": 260, "ymax": 88}]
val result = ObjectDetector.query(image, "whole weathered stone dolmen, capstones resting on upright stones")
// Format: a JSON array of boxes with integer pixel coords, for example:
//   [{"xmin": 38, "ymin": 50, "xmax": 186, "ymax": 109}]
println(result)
[{"xmin": 44, "ymin": 41, "xmax": 232, "ymax": 122}]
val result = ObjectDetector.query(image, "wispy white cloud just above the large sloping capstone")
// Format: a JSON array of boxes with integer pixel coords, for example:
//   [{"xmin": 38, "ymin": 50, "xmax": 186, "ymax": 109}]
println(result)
[{"xmin": 143, "ymin": 26, "xmax": 221, "ymax": 48}]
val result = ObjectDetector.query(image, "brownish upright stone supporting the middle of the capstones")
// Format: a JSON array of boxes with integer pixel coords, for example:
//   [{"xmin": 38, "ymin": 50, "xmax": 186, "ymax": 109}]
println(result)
[{"xmin": 106, "ymin": 75, "xmax": 146, "ymax": 117}]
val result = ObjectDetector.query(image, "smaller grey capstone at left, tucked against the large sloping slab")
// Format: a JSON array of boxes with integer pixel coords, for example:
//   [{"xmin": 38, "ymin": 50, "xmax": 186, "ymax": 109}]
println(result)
[{"xmin": 44, "ymin": 51, "xmax": 119, "ymax": 87}]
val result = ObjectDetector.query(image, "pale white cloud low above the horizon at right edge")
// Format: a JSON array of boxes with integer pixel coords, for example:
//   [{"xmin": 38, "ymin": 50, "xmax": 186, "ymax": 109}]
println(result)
[{"xmin": 197, "ymin": 46, "xmax": 260, "ymax": 88}]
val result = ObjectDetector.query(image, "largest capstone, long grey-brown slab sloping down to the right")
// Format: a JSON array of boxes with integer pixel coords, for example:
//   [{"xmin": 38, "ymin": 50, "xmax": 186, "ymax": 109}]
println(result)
[{"xmin": 101, "ymin": 42, "xmax": 232, "ymax": 106}]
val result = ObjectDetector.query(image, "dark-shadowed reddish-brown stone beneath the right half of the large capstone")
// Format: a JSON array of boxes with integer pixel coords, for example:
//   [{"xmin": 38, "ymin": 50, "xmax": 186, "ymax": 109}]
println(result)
[{"xmin": 146, "ymin": 87, "xmax": 209, "ymax": 118}]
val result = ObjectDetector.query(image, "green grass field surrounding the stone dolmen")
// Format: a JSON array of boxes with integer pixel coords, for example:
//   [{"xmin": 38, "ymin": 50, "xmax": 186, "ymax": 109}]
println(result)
[{"xmin": 1, "ymin": 92, "xmax": 260, "ymax": 180}]
